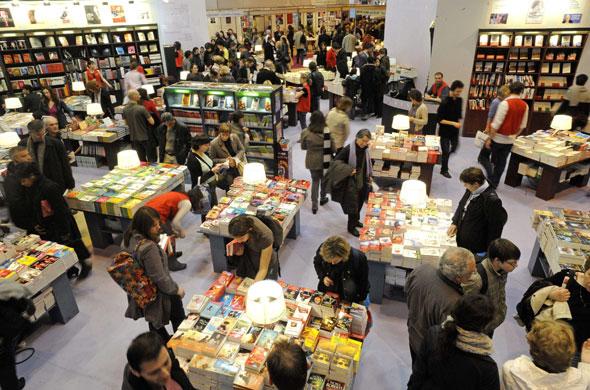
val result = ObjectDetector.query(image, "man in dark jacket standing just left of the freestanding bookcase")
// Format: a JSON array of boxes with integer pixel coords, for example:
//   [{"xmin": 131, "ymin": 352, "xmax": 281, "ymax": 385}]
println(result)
[{"xmin": 157, "ymin": 112, "xmax": 191, "ymax": 165}]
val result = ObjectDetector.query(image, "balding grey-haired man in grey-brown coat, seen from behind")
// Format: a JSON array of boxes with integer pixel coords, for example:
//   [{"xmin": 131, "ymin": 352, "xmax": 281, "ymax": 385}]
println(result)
[{"xmin": 405, "ymin": 247, "xmax": 475, "ymax": 364}]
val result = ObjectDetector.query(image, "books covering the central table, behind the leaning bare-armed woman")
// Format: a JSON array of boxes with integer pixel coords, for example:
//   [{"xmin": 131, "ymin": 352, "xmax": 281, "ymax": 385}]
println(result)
[{"xmin": 201, "ymin": 176, "xmax": 310, "ymax": 236}]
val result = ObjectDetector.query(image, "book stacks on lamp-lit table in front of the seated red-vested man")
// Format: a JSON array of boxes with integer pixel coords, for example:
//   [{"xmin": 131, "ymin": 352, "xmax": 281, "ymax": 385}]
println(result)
[{"xmin": 369, "ymin": 128, "xmax": 440, "ymax": 164}]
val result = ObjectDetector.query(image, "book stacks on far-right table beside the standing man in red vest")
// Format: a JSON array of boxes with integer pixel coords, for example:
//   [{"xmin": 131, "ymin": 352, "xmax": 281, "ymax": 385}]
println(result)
[{"xmin": 512, "ymin": 130, "xmax": 590, "ymax": 168}]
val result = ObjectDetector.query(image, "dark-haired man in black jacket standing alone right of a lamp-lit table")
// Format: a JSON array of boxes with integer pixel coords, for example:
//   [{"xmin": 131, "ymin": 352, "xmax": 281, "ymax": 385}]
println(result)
[{"xmin": 447, "ymin": 167, "xmax": 508, "ymax": 255}]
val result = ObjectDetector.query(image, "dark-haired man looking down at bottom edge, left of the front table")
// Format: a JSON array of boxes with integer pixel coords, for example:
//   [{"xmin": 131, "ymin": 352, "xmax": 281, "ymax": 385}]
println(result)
[{"xmin": 121, "ymin": 332, "xmax": 194, "ymax": 390}]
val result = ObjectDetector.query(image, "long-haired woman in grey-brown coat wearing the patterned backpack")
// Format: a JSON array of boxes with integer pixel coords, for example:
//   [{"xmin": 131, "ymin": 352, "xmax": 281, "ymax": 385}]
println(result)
[{"xmin": 121, "ymin": 206, "xmax": 185, "ymax": 342}]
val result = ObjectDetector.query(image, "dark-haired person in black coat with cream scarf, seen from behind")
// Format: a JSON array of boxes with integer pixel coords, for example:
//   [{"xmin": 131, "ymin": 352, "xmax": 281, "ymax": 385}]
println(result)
[{"xmin": 408, "ymin": 290, "xmax": 500, "ymax": 390}]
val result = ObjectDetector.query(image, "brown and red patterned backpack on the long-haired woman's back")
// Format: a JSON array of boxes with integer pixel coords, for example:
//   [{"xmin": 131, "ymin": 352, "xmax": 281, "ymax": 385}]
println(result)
[{"xmin": 107, "ymin": 240, "xmax": 157, "ymax": 309}]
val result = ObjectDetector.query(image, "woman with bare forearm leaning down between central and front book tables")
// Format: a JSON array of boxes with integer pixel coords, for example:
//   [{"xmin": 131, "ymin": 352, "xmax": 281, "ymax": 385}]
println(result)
[{"xmin": 228, "ymin": 215, "xmax": 279, "ymax": 281}]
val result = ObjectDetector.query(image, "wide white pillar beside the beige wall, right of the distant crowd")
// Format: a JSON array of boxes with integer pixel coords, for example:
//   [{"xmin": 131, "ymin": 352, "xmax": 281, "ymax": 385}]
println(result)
[{"xmin": 385, "ymin": 0, "xmax": 438, "ymax": 90}]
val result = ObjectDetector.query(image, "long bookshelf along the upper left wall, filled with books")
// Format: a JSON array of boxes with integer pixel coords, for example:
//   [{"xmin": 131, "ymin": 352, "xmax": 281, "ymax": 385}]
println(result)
[{"xmin": 0, "ymin": 25, "xmax": 163, "ymax": 103}]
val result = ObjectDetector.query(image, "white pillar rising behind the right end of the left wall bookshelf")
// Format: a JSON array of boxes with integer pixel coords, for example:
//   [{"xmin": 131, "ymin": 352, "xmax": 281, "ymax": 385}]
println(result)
[{"xmin": 151, "ymin": 0, "xmax": 209, "ymax": 50}]
